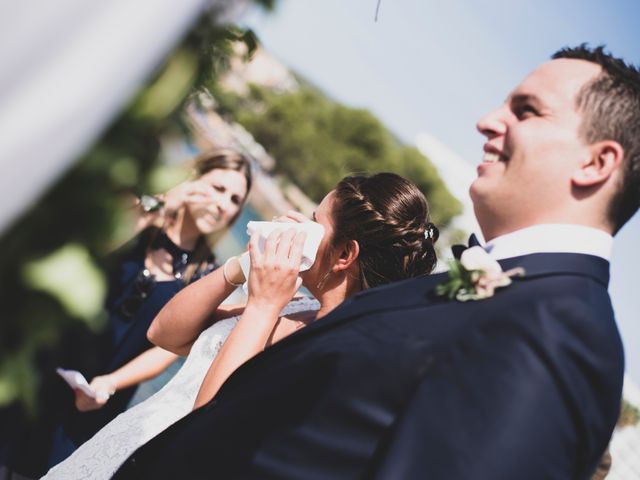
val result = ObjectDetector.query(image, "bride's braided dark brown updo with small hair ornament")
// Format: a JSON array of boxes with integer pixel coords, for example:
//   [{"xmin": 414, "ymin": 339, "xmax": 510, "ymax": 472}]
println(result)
[{"xmin": 332, "ymin": 173, "xmax": 439, "ymax": 289}]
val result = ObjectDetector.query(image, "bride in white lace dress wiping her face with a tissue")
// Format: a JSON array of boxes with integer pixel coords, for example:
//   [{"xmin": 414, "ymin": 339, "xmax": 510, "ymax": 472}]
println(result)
[{"xmin": 43, "ymin": 173, "xmax": 438, "ymax": 480}]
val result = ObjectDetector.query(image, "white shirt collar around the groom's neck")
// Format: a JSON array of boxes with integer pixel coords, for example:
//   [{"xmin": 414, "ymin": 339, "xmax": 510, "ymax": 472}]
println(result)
[{"xmin": 485, "ymin": 224, "xmax": 613, "ymax": 260}]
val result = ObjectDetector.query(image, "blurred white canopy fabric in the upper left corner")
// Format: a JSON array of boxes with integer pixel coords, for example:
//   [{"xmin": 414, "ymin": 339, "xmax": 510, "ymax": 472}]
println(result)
[{"xmin": 0, "ymin": 0, "xmax": 246, "ymax": 234}]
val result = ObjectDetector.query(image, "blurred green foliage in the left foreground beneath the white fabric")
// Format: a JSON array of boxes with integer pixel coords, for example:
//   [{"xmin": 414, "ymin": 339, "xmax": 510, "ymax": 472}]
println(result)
[{"xmin": 0, "ymin": 0, "xmax": 274, "ymax": 413}]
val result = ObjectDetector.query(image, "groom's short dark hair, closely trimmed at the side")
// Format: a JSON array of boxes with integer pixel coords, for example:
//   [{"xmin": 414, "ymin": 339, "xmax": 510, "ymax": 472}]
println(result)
[{"xmin": 551, "ymin": 43, "xmax": 640, "ymax": 233}]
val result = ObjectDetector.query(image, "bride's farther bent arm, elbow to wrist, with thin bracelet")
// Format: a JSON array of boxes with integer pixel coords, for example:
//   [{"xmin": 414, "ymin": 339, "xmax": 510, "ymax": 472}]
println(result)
[{"xmin": 147, "ymin": 257, "xmax": 244, "ymax": 355}]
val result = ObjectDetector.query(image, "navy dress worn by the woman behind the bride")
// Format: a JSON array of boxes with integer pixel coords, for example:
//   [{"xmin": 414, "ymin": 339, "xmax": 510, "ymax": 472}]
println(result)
[{"xmin": 42, "ymin": 228, "xmax": 217, "ymax": 473}]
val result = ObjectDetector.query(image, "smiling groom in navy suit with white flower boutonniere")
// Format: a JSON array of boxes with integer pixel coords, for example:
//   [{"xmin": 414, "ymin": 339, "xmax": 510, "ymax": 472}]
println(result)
[{"xmin": 115, "ymin": 47, "xmax": 640, "ymax": 480}]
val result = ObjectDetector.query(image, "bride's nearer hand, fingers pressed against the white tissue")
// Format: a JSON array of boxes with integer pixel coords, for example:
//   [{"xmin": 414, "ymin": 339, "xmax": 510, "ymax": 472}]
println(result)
[{"xmin": 248, "ymin": 225, "xmax": 306, "ymax": 315}]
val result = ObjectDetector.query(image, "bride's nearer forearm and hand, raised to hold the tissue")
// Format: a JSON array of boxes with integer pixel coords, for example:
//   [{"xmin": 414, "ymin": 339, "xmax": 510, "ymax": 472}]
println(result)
[{"xmin": 194, "ymin": 229, "xmax": 305, "ymax": 408}]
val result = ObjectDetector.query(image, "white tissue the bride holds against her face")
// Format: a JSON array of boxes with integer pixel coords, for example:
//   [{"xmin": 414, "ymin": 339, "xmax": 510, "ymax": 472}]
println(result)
[{"xmin": 238, "ymin": 221, "xmax": 324, "ymax": 279}]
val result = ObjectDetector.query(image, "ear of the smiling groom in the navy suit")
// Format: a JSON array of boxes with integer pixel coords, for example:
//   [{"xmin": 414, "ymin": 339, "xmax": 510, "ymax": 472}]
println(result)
[{"xmin": 571, "ymin": 140, "xmax": 624, "ymax": 187}]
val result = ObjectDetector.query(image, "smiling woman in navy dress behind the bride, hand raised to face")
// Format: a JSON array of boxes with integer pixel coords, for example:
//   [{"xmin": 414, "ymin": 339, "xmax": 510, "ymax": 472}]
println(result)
[{"xmin": 7, "ymin": 149, "xmax": 251, "ymax": 476}]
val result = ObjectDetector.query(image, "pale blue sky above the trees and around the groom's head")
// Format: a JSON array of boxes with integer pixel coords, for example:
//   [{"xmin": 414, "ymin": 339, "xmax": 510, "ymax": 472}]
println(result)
[{"xmin": 245, "ymin": 0, "xmax": 640, "ymax": 382}]
